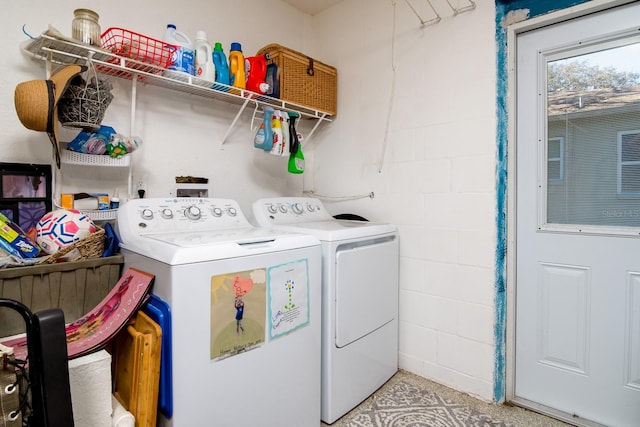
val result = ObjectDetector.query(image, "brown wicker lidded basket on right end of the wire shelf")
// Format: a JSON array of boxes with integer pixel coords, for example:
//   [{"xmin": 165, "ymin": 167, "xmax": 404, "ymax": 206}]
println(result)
[{"xmin": 256, "ymin": 43, "xmax": 338, "ymax": 115}]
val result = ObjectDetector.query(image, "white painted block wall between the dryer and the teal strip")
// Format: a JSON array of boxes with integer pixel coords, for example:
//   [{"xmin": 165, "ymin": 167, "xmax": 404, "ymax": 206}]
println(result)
[{"xmin": 312, "ymin": 0, "xmax": 496, "ymax": 400}]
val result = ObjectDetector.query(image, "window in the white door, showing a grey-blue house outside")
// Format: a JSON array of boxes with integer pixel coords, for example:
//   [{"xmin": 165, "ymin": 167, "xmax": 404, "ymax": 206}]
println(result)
[{"xmin": 539, "ymin": 39, "xmax": 640, "ymax": 234}]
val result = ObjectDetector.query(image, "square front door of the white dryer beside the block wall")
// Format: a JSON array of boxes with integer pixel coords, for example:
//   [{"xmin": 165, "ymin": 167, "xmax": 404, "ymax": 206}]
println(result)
[{"xmin": 335, "ymin": 234, "xmax": 398, "ymax": 347}]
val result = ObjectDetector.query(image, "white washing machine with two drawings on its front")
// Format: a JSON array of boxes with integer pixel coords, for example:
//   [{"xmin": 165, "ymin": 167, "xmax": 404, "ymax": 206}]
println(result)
[{"xmin": 118, "ymin": 198, "xmax": 321, "ymax": 427}]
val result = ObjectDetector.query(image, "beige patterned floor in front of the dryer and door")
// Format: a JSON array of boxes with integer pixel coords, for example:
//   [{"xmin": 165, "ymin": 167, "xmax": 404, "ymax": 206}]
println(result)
[{"xmin": 321, "ymin": 370, "xmax": 570, "ymax": 427}]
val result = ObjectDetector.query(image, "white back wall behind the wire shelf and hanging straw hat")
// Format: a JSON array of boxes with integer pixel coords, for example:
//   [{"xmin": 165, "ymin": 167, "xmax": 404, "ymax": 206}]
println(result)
[{"xmin": 0, "ymin": 0, "xmax": 318, "ymax": 214}]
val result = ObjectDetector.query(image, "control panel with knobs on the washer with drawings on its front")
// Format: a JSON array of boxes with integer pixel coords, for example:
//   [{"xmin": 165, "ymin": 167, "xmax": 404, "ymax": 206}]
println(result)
[{"xmin": 118, "ymin": 197, "xmax": 251, "ymax": 235}]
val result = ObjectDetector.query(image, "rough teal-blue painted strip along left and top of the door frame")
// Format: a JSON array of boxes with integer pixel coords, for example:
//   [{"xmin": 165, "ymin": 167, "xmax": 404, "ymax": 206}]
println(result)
[{"xmin": 493, "ymin": 0, "xmax": 589, "ymax": 403}]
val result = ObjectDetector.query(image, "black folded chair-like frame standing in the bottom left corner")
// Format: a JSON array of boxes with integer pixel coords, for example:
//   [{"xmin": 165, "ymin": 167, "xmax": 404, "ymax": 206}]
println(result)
[{"xmin": 0, "ymin": 298, "xmax": 74, "ymax": 427}]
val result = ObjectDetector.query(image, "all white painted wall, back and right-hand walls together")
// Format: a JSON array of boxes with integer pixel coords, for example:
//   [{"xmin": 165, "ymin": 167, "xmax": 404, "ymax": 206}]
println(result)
[{"xmin": 0, "ymin": 0, "xmax": 496, "ymax": 400}]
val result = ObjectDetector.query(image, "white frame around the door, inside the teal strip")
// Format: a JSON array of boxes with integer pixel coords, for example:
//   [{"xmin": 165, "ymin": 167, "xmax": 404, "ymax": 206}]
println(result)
[{"xmin": 504, "ymin": 0, "xmax": 637, "ymax": 426}]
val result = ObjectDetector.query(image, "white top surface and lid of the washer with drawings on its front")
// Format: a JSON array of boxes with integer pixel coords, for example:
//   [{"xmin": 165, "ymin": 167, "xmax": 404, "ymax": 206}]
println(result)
[{"xmin": 120, "ymin": 227, "xmax": 320, "ymax": 265}]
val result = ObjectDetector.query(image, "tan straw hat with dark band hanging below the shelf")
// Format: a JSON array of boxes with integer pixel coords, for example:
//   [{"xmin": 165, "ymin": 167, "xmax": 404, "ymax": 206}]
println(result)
[{"xmin": 14, "ymin": 65, "xmax": 86, "ymax": 168}]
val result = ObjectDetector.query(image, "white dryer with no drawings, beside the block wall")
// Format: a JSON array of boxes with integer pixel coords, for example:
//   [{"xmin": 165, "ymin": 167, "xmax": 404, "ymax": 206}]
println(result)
[{"xmin": 252, "ymin": 197, "xmax": 399, "ymax": 424}]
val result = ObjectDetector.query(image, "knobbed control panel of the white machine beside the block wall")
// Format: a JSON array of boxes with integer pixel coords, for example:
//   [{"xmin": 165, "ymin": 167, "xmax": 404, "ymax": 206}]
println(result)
[{"xmin": 252, "ymin": 197, "xmax": 333, "ymax": 225}]
